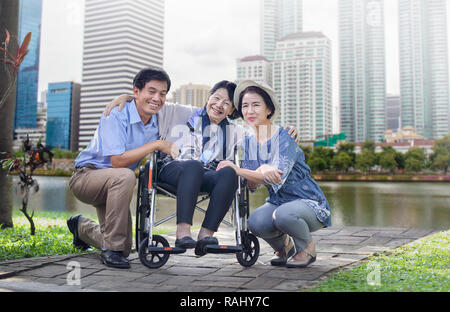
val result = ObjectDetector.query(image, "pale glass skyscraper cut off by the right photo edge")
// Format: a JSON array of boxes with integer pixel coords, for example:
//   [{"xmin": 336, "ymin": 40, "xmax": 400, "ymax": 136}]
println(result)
[{"xmin": 398, "ymin": 0, "xmax": 450, "ymax": 139}]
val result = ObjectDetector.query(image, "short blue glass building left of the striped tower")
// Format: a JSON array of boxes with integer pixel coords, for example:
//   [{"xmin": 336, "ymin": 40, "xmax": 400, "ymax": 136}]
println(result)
[{"xmin": 46, "ymin": 82, "xmax": 81, "ymax": 152}]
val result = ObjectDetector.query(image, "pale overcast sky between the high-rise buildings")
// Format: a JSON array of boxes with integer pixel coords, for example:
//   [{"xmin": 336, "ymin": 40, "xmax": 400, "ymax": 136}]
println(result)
[{"xmin": 39, "ymin": 0, "xmax": 450, "ymax": 127}]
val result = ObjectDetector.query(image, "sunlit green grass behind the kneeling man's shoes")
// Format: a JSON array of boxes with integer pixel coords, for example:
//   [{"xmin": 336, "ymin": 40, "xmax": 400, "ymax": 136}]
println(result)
[{"xmin": 0, "ymin": 211, "xmax": 170, "ymax": 262}]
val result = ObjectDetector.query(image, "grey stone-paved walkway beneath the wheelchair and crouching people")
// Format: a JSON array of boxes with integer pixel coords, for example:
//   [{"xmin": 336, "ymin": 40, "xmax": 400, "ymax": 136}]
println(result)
[{"xmin": 0, "ymin": 227, "xmax": 436, "ymax": 292}]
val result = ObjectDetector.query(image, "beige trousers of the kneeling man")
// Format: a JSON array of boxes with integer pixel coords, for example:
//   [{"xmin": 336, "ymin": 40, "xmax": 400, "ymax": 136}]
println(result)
[{"xmin": 69, "ymin": 168, "xmax": 136, "ymax": 257}]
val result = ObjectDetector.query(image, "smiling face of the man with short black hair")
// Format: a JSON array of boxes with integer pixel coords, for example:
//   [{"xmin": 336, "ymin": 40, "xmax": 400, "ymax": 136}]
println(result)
[{"xmin": 133, "ymin": 80, "xmax": 167, "ymax": 124}]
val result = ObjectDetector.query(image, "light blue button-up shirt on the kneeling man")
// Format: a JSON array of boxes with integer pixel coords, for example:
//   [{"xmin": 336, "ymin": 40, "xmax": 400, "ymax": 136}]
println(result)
[{"xmin": 74, "ymin": 100, "xmax": 159, "ymax": 170}]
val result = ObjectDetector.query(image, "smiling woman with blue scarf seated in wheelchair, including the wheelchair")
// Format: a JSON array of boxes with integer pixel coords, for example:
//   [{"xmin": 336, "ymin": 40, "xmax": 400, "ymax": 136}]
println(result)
[{"xmin": 103, "ymin": 80, "xmax": 297, "ymax": 268}]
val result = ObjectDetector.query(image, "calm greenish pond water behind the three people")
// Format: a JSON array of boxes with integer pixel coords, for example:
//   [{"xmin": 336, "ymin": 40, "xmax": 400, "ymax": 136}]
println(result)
[{"xmin": 7, "ymin": 177, "xmax": 450, "ymax": 229}]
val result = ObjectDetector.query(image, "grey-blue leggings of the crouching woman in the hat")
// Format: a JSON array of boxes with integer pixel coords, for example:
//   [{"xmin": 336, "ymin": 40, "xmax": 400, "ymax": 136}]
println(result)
[{"xmin": 248, "ymin": 199, "xmax": 324, "ymax": 252}]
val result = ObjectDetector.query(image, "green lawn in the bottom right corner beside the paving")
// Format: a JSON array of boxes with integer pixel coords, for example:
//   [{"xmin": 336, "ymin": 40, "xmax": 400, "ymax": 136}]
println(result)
[{"xmin": 306, "ymin": 231, "xmax": 450, "ymax": 292}]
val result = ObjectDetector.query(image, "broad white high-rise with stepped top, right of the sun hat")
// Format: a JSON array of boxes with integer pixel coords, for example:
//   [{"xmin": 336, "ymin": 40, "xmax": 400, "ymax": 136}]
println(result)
[{"xmin": 273, "ymin": 32, "xmax": 333, "ymax": 141}]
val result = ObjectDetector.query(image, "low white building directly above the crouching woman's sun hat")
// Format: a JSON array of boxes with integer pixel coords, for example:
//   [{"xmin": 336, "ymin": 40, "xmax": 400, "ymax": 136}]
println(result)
[{"xmin": 237, "ymin": 55, "xmax": 272, "ymax": 86}]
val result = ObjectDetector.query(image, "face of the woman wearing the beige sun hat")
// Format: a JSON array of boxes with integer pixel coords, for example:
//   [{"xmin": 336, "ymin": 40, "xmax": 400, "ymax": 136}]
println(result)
[{"xmin": 241, "ymin": 92, "xmax": 272, "ymax": 127}]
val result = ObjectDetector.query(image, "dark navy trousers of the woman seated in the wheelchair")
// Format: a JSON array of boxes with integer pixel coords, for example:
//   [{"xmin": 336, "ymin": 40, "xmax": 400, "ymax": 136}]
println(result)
[{"xmin": 159, "ymin": 160, "xmax": 238, "ymax": 232}]
